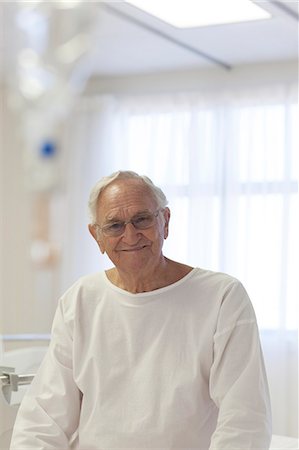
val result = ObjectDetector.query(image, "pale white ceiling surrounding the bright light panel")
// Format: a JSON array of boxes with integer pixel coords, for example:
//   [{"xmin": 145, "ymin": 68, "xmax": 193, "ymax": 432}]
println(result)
[{"xmin": 0, "ymin": 0, "xmax": 299, "ymax": 84}]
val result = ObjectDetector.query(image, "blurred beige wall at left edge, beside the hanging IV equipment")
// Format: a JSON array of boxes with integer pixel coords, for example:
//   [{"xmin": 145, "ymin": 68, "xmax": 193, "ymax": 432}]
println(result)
[{"xmin": 0, "ymin": 85, "xmax": 55, "ymax": 349}]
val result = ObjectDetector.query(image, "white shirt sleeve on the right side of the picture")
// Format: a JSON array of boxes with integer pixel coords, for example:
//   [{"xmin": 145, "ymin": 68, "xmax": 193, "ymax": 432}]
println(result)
[{"xmin": 210, "ymin": 282, "xmax": 271, "ymax": 450}]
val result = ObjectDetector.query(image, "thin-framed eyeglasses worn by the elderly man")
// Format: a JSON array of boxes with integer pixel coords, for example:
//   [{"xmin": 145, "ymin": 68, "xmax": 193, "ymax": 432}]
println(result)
[{"xmin": 95, "ymin": 209, "xmax": 163, "ymax": 236}]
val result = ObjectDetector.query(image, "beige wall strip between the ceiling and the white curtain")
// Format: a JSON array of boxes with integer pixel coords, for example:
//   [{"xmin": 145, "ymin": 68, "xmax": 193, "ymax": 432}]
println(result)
[{"xmin": 86, "ymin": 61, "xmax": 298, "ymax": 95}]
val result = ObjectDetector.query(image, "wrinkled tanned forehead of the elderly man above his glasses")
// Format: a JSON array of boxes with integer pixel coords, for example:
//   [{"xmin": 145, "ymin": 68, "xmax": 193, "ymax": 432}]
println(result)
[{"xmin": 97, "ymin": 179, "xmax": 158, "ymax": 217}]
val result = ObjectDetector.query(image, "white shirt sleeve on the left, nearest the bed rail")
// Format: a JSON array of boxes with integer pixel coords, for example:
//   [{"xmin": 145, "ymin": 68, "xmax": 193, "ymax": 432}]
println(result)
[{"xmin": 10, "ymin": 302, "xmax": 81, "ymax": 450}]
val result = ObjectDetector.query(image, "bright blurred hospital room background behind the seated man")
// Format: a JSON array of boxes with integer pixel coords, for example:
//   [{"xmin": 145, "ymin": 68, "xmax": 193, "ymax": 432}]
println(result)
[{"xmin": 0, "ymin": 0, "xmax": 299, "ymax": 439}]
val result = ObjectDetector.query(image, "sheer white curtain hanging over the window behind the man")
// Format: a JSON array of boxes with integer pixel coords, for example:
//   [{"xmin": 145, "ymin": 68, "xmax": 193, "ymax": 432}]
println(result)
[{"xmin": 63, "ymin": 85, "xmax": 299, "ymax": 436}]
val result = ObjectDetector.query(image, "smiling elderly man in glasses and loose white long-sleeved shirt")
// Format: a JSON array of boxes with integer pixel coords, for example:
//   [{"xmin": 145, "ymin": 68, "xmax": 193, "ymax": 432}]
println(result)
[{"xmin": 11, "ymin": 172, "xmax": 271, "ymax": 450}]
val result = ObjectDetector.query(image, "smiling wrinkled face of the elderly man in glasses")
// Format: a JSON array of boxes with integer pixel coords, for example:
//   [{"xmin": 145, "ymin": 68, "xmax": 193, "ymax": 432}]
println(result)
[{"xmin": 90, "ymin": 179, "xmax": 170, "ymax": 272}]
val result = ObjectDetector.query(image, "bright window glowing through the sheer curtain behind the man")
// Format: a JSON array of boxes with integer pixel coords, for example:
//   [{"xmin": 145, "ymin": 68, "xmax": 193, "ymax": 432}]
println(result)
[{"xmin": 118, "ymin": 96, "xmax": 299, "ymax": 329}]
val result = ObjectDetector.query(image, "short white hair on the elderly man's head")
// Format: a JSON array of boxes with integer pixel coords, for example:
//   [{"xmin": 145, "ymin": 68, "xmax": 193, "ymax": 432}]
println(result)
[{"xmin": 88, "ymin": 170, "xmax": 168, "ymax": 225}]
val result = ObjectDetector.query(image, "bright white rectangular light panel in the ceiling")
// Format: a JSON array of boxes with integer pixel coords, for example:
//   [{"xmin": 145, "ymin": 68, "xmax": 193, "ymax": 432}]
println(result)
[{"xmin": 126, "ymin": 0, "xmax": 271, "ymax": 28}]
